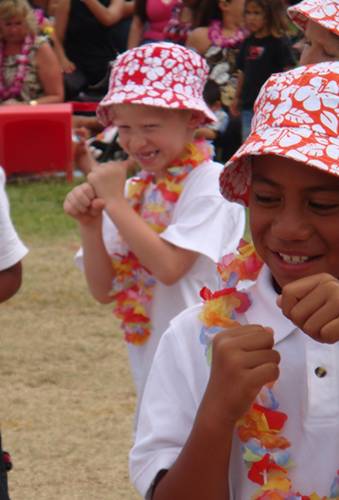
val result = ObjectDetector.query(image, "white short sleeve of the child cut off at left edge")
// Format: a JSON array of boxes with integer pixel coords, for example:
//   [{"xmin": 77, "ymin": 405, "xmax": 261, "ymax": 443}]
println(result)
[{"xmin": 0, "ymin": 167, "xmax": 28, "ymax": 271}]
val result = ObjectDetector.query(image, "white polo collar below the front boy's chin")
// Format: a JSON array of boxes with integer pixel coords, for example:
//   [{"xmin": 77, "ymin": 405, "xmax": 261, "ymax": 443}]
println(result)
[{"xmin": 245, "ymin": 265, "xmax": 297, "ymax": 344}]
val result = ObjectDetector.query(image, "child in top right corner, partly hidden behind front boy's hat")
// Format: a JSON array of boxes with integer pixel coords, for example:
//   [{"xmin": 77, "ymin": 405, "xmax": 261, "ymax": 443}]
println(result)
[{"xmin": 287, "ymin": 0, "xmax": 339, "ymax": 64}]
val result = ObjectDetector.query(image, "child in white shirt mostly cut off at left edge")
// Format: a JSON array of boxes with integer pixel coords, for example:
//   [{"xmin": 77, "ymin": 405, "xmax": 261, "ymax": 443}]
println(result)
[{"xmin": 0, "ymin": 167, "xmax": 27, "ymax": 500}]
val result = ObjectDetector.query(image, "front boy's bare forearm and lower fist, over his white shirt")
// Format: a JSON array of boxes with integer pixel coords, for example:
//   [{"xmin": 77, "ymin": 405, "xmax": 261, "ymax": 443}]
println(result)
[{"xmin": 152, "ymin": 325, "xmax": 280, "ymax": 500}]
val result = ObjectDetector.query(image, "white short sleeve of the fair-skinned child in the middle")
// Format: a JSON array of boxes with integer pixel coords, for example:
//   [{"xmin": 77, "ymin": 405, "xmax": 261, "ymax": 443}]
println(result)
[{"xmin": 161, "ymin": 162, "xmax": 245, "ymax": 262}]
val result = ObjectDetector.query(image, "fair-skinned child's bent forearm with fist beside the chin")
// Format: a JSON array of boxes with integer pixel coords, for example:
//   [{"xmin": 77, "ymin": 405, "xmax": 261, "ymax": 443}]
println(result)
[{"xmin": 88, "ymin": 161, "xmax": 198, "ymax": 285}]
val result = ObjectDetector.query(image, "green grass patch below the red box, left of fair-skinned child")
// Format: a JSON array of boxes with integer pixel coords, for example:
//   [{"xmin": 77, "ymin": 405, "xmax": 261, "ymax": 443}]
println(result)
[{"xmin": 6, "ymin": 177, "xmax": 82, "ymax": 242}]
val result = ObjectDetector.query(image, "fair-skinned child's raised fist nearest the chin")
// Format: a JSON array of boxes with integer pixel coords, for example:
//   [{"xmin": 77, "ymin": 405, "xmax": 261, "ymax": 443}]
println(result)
[{"xmin": 87, "ymin": 160, "xmax": 130, "ymax": 205}]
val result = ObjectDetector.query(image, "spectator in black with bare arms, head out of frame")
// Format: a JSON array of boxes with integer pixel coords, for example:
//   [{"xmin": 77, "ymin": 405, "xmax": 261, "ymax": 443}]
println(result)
[{"xmin": 55, "ymin": 0, "xmax": 124, "ymax": 100}]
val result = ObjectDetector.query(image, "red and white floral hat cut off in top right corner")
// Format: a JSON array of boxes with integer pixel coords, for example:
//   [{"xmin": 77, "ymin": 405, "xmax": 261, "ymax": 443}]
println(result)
[{"xmin": 287, "ymin": 0, "xmax": 339, "ymax": 36}]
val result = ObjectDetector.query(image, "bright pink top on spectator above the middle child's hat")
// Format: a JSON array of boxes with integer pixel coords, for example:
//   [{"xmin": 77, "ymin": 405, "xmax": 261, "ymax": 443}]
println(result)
[{"xmin": 143, "ymin": 0, "xmax": 180, "ymax": 41}]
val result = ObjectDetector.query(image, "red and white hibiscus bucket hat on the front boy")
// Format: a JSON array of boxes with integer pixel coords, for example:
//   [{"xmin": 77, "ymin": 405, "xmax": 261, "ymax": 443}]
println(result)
[{"xmin": 220, "ymin": 61, "xmax": 339, "ymax": 205}]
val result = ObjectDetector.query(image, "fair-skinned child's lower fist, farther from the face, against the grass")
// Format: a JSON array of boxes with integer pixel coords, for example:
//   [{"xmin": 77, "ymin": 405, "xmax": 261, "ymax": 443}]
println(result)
[{"xmin": 64, "ymin": 182, "xmax": 105, "ymax": 225}]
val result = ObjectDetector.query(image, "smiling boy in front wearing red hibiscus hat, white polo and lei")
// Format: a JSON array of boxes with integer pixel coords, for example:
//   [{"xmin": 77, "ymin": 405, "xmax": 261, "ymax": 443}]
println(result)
[{"xmin": 130, "ymin": 62, "xmax": 339, "ymax": 500}]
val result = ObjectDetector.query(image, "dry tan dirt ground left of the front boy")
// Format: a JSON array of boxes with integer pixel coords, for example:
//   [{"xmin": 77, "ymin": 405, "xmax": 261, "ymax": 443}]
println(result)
[{"xmin": 0, "ymin": 241, "xmax": 140, "ymax": 500}]
